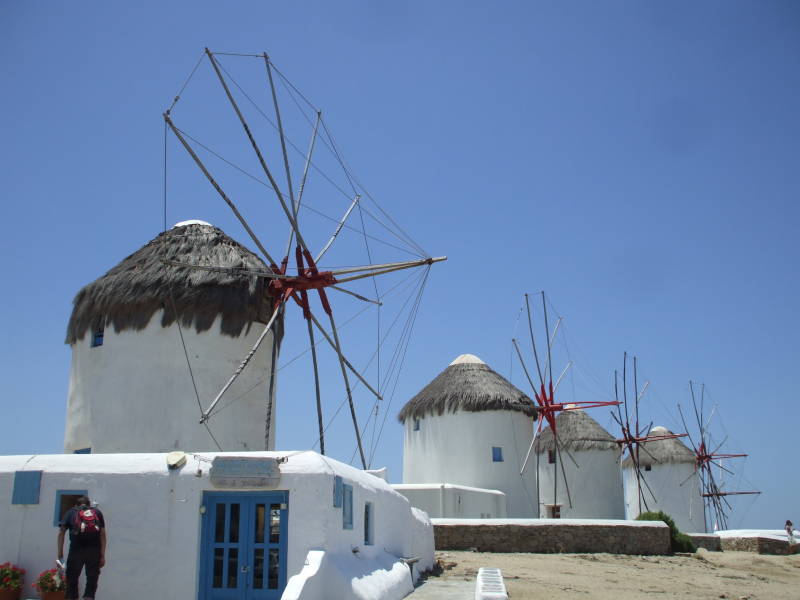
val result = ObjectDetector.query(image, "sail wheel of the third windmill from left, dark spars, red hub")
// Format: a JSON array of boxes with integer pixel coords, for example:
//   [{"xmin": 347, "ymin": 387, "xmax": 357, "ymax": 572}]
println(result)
[{"xmin": 611, "ymin": 352, "xmax": 686, "ymax": 514}]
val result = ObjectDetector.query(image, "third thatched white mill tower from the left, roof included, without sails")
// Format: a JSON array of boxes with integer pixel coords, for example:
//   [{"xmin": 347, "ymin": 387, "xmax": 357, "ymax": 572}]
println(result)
[{"xmin": 528, "ymin": 409, "xmax": 625, "ymax": 519}]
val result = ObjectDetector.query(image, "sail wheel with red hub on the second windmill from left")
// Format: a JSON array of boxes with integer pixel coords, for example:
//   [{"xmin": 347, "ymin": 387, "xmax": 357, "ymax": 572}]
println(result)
[{"xmin": 511, "ymin": 291, "xmax": 618, "ymax": 516}]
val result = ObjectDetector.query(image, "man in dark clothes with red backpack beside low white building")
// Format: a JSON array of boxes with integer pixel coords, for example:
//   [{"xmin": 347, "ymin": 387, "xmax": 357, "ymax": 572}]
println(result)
[{"xmin": 58, "ymin": 496, "xmax": 106, "ymax": 600}]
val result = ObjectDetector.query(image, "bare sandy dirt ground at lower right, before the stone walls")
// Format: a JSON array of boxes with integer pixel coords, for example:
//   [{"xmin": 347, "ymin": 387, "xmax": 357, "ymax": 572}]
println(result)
[{"xmin": 428, "ymin": 550, "xmax": 800, "ymax": 600}]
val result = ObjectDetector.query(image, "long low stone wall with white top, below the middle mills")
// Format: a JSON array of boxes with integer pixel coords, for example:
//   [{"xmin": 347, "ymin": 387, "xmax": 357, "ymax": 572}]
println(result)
[{"xmin": 433, "ymin": 519, "xmax": 670, "ymax": 554}]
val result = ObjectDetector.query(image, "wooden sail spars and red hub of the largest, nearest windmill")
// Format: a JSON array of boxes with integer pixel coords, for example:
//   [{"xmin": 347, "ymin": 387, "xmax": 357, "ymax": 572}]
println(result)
[{"xmin": 158, "ymin": 48, "xmax": 446, "ymax": 468}]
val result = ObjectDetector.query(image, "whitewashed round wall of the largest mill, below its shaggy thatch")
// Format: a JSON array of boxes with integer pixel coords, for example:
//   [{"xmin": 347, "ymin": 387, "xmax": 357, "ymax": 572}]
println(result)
[{"xmin": 64, "ymin": 311, "xmax": 277, "ymax": 453}]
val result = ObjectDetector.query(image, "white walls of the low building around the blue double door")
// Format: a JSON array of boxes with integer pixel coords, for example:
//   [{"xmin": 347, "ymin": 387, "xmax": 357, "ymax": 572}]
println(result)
[{"xmin": 0, "ymin": 452, "xmax": 433, "ymax": 600}]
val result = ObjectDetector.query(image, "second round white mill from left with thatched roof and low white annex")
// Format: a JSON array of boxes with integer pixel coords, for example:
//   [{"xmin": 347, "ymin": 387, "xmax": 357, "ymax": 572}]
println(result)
[{"xmin": 395, "ymin": 354, "xmax": 537, "ymax": 518}]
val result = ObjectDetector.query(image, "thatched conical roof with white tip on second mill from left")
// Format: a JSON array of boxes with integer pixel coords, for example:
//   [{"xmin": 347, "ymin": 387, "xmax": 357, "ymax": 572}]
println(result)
[{"xmin": 397, "ymin": 354, "xmax": 537, "ymax": 423}]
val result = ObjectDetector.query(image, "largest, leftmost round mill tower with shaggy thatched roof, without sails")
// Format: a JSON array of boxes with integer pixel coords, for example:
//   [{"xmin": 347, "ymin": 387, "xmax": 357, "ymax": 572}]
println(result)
[{"xmin": 64, "ymin": 221, "xmax": 283, "ymax": 453}]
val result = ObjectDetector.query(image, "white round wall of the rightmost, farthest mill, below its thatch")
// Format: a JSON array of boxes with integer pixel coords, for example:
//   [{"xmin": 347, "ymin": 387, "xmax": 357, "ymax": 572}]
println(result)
[{"xmin": 623, "ymin": 462, "xmax": 706, "ymax": 533}]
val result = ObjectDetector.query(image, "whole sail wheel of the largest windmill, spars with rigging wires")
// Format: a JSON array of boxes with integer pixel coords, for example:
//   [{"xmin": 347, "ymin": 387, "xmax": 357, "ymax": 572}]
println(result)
[{"xmin": 158, "ymin": 48, "xmax": 446, "ymax": 468}]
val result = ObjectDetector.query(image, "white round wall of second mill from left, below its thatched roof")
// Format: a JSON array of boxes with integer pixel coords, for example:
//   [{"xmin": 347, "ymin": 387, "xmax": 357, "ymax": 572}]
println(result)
[{"xmin": 403, "ymin": 410, "xmax": 536, "ymax": 518}]
